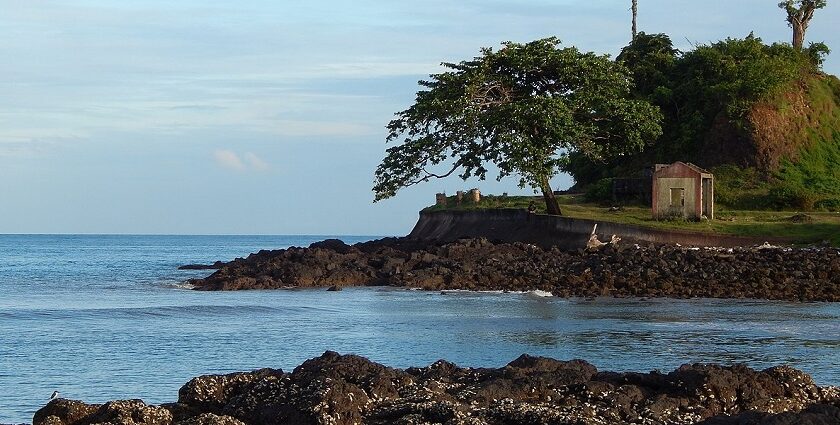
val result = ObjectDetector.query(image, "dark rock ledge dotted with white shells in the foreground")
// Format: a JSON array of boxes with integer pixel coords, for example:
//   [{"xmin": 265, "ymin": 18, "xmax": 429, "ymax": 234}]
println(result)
[{"xmin": 33, "ymin": 351, "xmax": 840, "ymax": 425}]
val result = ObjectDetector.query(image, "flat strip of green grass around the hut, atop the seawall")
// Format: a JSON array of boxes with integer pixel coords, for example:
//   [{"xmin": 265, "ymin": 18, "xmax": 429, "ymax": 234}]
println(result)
[{"xmin": 424, "ymin": 195, "xmax": 840, "ymax": 246}]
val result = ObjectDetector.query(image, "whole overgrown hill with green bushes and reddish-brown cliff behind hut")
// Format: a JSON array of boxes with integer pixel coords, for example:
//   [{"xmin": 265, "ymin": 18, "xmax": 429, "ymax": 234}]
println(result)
[{"xmin": 569, "ymin": 33, "xmax": 840, "ymax": 210}]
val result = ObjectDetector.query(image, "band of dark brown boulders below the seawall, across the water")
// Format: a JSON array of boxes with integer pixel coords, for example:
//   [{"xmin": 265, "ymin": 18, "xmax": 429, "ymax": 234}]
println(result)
[{"xmin": 190, "ymin": 238, "xmax": 840, "ymax": 301}]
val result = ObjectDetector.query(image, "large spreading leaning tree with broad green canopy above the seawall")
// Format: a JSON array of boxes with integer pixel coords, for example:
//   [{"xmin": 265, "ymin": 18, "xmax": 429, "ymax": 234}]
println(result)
[{"xmin": 373, "ymin": 37, "xmax": 661, "ymax": 215}]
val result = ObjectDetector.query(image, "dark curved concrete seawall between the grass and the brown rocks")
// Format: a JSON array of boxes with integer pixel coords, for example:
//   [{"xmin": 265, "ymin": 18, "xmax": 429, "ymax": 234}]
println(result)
[{"xmin": 408, "ymin": 209, "xmax": 788, "ymax": 250}]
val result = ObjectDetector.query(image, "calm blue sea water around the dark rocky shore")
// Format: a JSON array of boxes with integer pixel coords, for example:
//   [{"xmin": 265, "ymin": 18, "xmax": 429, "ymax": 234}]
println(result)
[{"xmin": 0, "ymin": 235, "xmax": 840, "ymax": 423}]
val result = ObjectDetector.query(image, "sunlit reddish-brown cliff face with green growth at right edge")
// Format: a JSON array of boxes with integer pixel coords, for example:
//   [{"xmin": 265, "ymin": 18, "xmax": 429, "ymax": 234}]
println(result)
[{"xmin": 712, "ymin": 75, "xmax": 840, "ymax": 211}]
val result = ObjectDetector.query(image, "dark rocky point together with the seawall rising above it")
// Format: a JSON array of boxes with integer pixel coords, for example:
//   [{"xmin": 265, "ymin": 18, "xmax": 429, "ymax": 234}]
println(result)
[{"xmin": 185, "ymin": 211, "xmax": 840, "ymax": 302}]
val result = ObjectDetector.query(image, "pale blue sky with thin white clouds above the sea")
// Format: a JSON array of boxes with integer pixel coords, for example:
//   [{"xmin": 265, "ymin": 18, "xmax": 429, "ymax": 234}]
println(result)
[{"xmin": 0, "ymin": 0, "xmax": 840, "ymax": 236}]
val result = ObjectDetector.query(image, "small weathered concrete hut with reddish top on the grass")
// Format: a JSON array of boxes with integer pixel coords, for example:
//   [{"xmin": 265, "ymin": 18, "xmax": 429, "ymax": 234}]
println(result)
[{"xmin": 652, "ymin": 161, "xmax": 715, "ymax": 220}]
